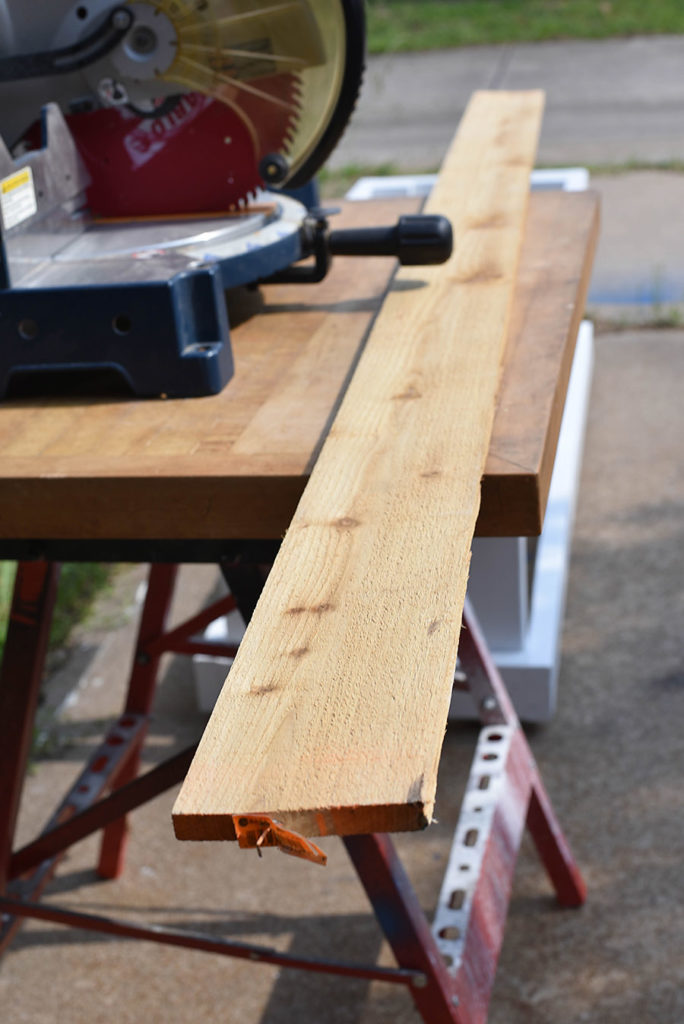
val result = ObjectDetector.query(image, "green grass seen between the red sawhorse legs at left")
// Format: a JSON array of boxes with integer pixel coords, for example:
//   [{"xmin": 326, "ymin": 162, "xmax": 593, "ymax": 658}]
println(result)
[{"xmin": 0, "ymin": 562, "xmax": 112, "ymax": 656}]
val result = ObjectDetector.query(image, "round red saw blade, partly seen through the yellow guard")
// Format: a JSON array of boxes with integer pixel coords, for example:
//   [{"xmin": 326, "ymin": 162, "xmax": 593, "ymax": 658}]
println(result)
[{"xmin": 63, "ymin": 0, "xmax": 339, "ymax": 216}]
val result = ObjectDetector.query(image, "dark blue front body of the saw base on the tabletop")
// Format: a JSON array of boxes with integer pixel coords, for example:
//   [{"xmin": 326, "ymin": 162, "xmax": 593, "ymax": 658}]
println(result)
[{"xmin": 0, "ymin": 268, "xmax": 233, "ymax": 398}]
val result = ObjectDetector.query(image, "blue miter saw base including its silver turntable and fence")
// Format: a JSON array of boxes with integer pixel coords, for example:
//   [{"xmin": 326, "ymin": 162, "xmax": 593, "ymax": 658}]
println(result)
[{"xmin": 0, "ymin": 103, "xmax": 306, "ymax": 400}]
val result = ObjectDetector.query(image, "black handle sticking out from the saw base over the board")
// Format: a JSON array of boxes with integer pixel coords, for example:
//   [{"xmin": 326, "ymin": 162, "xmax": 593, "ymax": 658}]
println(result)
[{"xmin": 328, "ymin": 214, "xmax": 454, "ymax": 266}]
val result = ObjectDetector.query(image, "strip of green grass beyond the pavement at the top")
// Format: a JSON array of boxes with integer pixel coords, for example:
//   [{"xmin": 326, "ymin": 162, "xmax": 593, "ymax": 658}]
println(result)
[{"xmin": 366, "ymin": 0, "xmax": 684, "ymax": 53}]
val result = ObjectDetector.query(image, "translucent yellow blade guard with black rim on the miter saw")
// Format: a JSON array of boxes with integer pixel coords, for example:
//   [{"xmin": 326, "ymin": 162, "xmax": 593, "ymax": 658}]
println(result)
[{"xmin": 131, "ymin": 0, "xmax": 365, "ymax": 195}]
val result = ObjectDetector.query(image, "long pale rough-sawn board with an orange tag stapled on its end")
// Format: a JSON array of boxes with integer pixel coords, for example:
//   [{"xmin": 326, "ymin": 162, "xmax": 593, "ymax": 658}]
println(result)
[{"xmin": 174, "ymin": 92, "xmax": 543, "ymax": 839}]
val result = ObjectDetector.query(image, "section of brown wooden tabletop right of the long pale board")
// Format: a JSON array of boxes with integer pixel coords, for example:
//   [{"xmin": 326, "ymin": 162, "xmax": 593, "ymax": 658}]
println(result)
[{"xmin": 475, "ymin": 190, "xmax": 599, "ymax": 537}]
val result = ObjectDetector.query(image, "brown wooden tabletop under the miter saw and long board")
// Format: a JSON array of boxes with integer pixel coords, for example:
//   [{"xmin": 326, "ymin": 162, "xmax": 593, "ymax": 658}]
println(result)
[{"xmin": 0, "ymin": 185, "xmax": 596, "ymax": 540}]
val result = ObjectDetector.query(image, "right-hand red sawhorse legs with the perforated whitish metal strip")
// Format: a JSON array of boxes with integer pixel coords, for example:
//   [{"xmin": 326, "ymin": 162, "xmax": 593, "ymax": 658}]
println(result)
[{"xmin": 344, "ymin": 607, "xmax": 586, "ymax": 1024}]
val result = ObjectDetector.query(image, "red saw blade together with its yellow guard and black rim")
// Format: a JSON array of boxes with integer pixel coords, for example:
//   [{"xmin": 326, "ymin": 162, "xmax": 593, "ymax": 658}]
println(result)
[{"xmin": 5, "ymin": 0, "xmax": 364, "ymax": 216}]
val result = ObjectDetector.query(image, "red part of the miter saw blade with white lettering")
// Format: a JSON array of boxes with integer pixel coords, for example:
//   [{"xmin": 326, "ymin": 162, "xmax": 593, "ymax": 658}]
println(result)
[{"xmin": 67, "ymin": 74, "xmax": 299, "ymax": 217}]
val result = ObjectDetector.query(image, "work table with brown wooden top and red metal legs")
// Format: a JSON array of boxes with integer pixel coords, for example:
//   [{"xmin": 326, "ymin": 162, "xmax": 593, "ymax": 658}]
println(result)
[{"xmin": 0, "ymin": 193, "xmax": 598, "ymax": 1024}]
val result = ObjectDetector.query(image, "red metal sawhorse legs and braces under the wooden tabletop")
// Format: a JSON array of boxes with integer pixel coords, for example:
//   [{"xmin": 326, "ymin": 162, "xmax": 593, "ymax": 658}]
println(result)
[{"xmin": 0, "ymin": 559, "xmax": 585, "ymax": 1024}]
